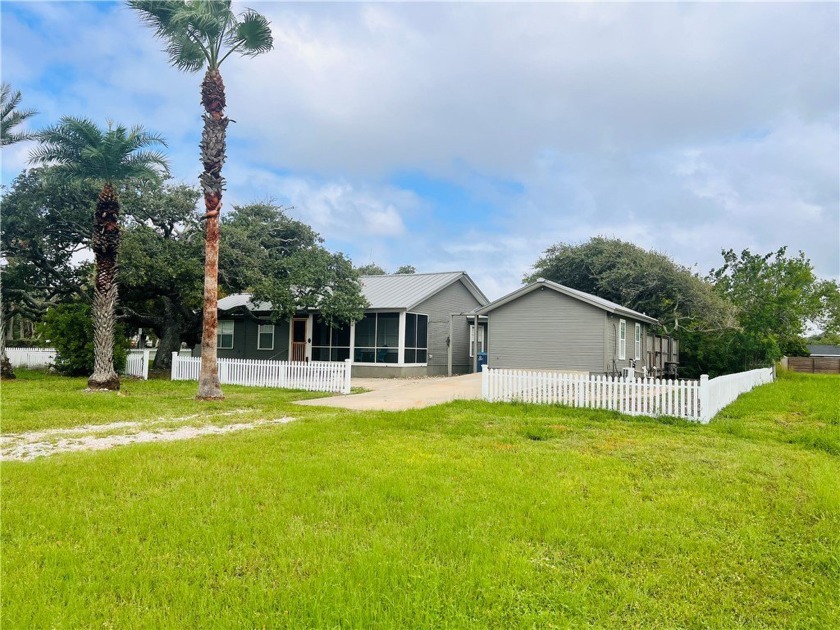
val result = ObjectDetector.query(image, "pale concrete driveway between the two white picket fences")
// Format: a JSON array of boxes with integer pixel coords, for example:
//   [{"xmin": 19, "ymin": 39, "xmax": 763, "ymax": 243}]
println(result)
[{"xmin": 297, "ymin": 373, "xmax": 481, "ymax": 411}]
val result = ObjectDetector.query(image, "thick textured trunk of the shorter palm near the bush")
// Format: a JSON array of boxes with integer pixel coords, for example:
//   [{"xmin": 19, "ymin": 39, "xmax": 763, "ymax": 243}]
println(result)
[{"xmin": 88, "ymin": 184, "xmax": 120, "ymax": 390}]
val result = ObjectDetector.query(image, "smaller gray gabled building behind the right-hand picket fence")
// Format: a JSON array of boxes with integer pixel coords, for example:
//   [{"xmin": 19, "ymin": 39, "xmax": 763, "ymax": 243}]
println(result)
[{"xmin": 476, "ymin": 278, "xmax": 676, "ymax": 374}]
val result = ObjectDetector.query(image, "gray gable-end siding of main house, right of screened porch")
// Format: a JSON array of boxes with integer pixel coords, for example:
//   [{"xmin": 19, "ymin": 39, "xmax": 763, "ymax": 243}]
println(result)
[{"xmin": 410, "ymin": 280, "xmax": 481, "ymax": 376}]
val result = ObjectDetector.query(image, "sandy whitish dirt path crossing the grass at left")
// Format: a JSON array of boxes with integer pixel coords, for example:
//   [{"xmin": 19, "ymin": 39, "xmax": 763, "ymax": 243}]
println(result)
[{"xmin": 0, "ymin": 412, "xmax": 294, "ymax": 462}]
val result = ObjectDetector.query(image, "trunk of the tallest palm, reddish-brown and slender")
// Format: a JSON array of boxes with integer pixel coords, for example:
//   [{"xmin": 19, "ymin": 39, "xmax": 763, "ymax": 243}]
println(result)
[{"xmin": 196, "ymin": 68, "xmax": 228, "ymax": 400}]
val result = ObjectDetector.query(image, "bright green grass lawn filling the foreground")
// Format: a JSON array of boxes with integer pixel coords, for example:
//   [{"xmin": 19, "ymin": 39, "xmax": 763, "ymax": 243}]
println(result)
[{"xmin": 0, "ymin": 374, "xmax": 840, "ymax": 628}]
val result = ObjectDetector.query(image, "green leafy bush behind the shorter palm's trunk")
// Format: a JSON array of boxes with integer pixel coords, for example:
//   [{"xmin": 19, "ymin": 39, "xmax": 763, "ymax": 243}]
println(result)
[{"xmin": 40, "ymin": 302, "xmax": 128, "ymax": 376}]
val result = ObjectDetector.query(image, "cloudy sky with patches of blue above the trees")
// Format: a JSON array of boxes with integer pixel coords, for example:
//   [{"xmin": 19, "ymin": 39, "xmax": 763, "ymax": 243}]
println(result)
[{"xmin": 0, "ymin": 0, "xmax": 840, "ymax": 298}]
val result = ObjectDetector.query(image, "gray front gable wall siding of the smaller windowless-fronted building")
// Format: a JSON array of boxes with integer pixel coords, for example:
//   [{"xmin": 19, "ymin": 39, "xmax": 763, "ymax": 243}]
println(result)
[{"xmin": 488, "ymin": 290, "xmax": 607, "ymax": 372}]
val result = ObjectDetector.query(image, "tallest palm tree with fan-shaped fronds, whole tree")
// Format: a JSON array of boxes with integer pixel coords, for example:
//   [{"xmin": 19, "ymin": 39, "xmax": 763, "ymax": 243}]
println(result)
[{"xmin": 128, "ymin": 0, "xmax": 273, "ymax": 400}]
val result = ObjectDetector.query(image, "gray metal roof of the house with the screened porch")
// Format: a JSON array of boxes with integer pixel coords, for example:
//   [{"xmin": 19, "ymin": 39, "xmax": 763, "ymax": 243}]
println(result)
[{"xmin": 219, "ymin": 271, "xmax": 489, "ymax": 312}]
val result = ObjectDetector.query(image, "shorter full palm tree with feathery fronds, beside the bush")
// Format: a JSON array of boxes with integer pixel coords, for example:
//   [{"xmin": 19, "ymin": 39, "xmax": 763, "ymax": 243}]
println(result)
[{"xmin": 30, "ymin": 116, "xmax": 169, "ymax": 390}]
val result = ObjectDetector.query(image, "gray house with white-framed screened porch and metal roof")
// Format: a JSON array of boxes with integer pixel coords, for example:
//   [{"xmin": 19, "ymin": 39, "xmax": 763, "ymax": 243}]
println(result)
[{"xmin": 206, "ymin": 271, "xmax": 489, "ymax": 377}]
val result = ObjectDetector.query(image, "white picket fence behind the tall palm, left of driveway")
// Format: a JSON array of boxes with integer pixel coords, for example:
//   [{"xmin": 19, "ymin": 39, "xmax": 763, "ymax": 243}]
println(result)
[{"xmin": 172, "ymin": 352, "xmax": 350, "ymax": 394}]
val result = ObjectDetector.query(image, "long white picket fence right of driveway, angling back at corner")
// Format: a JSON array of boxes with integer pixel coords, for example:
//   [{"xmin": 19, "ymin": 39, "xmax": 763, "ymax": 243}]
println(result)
[{"xmin": 482, "ymin": 368, "xmax": 773, "ymax": 423}]
